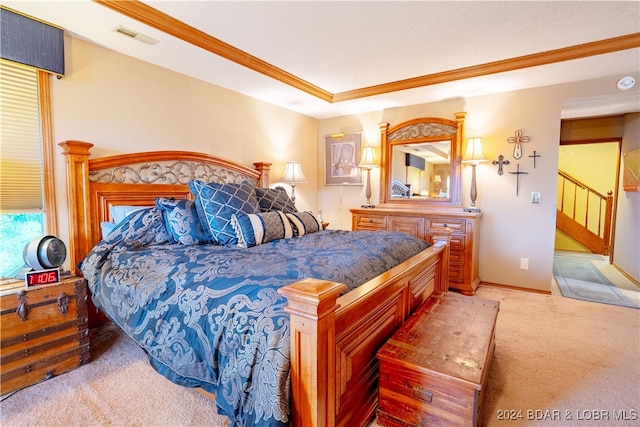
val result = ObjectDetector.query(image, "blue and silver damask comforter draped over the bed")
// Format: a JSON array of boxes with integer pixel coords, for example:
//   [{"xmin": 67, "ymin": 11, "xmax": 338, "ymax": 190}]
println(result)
[{"xmin": 81, "ymin": 208, "xmax": 428, "ymax": 426}]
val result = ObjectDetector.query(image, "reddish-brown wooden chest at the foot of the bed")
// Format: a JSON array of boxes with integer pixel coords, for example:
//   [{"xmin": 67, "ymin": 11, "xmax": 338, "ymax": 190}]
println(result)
[{"xmin": 377, "ymin": 293, "xmax": 500, "ymax": 426}]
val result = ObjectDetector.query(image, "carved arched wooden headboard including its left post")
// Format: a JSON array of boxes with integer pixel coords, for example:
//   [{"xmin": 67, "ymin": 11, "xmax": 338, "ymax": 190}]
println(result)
[{"xmin": 58, "ymin": 141, "xmax": 271, "ymax": 274}]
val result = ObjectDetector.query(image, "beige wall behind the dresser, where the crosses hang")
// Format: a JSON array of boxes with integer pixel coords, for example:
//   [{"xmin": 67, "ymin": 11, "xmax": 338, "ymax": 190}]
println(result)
[{"xmin": 318, "ymin": 76, "xmax": 640, "ymax": 290}]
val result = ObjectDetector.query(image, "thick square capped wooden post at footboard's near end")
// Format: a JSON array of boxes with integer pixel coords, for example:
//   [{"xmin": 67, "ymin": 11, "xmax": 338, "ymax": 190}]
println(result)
[{"xmin": 278, "ymin": 279, "xmax": 346, "ymax": 427}]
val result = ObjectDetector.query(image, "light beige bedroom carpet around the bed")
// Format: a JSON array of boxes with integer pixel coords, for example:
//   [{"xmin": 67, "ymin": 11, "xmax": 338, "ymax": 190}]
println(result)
[{"xmin": 0, "ymin": 286, "xmax": 640, "ymax": 427}]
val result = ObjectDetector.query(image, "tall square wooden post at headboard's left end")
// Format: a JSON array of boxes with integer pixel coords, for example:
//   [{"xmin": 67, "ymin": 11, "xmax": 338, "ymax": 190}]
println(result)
[{"xmin": 58, "ymin": 141, "xmax": 93, "ymax": 275}]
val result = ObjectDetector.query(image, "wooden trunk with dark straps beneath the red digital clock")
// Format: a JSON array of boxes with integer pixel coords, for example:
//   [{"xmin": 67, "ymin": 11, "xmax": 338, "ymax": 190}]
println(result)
[{"xmin": 0, "ymin": 277, "xmax": 90, "ymax": 396}]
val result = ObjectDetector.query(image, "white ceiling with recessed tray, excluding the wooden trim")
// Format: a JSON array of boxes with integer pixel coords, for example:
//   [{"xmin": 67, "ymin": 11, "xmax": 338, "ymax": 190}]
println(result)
[{"xmin": 0, "ymin": 0, "xmax": 640, "ymax": 118}]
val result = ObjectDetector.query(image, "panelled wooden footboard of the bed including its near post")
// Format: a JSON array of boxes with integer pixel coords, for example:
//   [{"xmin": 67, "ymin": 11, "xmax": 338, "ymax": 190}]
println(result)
[{"xmin": 278, "ymin": 242, "xmax": 449, "ymax": 427}]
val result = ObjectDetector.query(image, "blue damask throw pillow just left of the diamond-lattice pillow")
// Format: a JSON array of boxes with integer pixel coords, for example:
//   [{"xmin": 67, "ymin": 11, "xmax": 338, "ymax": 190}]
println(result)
[{"xmin": 156, "ymin": 197, "xmax": 209, "ymax": 245}]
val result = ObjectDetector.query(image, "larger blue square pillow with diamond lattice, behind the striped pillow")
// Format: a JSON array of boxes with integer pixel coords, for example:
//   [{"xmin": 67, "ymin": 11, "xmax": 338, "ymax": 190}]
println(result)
[{"xmin": 189, "ymin": 180, "xmax": 260, "ymax": 245}]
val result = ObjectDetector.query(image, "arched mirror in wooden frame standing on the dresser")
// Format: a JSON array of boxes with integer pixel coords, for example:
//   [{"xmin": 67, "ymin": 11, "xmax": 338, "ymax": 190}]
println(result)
[{"xmin": 380, "ymin": 113, "xmax": 466, "ymax": 207}]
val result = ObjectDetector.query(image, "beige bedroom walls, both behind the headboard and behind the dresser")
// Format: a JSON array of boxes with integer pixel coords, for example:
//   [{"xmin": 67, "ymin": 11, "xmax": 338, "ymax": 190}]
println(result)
[{"xmin": 51, "ymin": 38, "xmax": 640, "ymax": 290}]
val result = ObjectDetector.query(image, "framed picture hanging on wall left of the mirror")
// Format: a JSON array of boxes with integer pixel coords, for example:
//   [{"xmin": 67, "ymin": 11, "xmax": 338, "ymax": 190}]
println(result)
[{"xmin": 324, "ymin": 132, "xmax": 362, "ymax": 185}]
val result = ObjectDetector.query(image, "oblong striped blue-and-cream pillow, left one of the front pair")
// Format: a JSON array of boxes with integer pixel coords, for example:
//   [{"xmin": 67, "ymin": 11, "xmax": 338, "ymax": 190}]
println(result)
[{"xmin": 231, "ymin": 211, "xmax": 293, "ymax": 248}]
